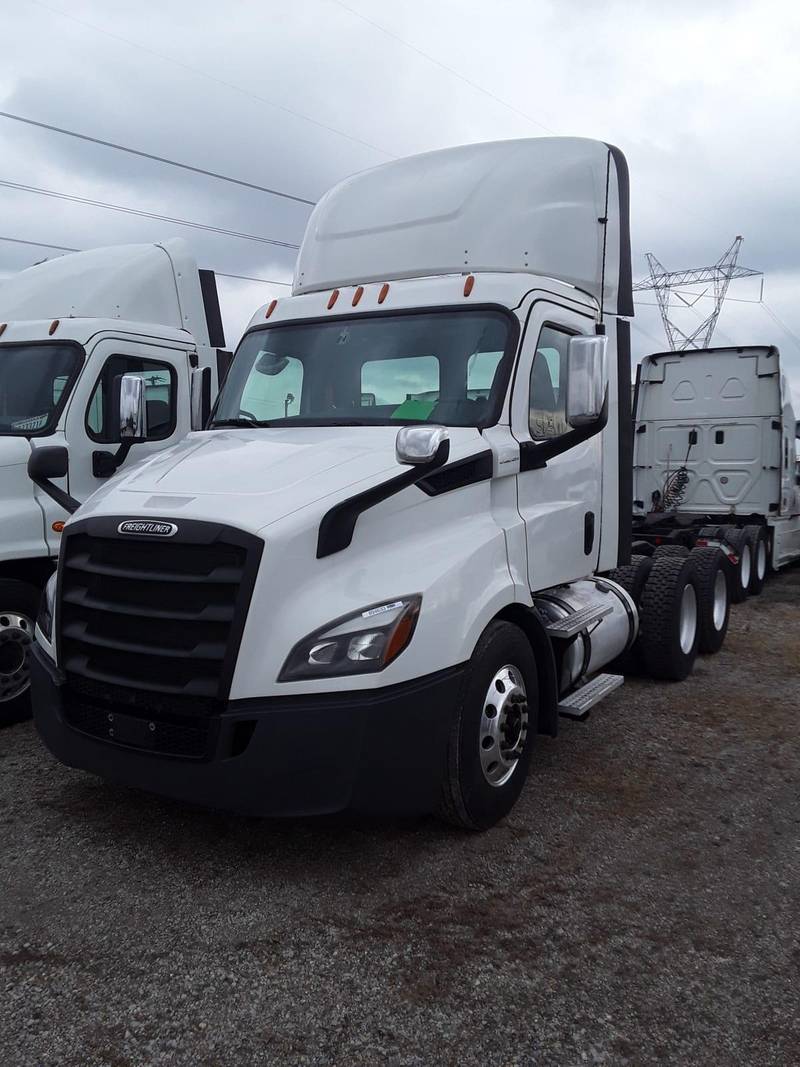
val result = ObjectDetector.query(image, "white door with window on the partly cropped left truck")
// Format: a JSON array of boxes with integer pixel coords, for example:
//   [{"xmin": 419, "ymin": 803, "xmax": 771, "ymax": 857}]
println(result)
[{"xmin": 66, "ymin": 338, "xmax": 190, "ymax": 501}]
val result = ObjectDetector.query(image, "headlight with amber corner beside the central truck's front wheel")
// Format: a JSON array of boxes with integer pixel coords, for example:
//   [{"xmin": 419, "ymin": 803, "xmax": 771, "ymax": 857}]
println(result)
[{"xmin": 278, "ymin": 595, "xmax": 422, "ymax": 682}]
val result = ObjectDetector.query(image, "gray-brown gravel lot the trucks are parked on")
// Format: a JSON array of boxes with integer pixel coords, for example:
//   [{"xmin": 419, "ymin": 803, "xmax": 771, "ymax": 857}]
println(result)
[{"xmin": 0, "ymin": 569, "xmax": 800, "ymax": 1067}]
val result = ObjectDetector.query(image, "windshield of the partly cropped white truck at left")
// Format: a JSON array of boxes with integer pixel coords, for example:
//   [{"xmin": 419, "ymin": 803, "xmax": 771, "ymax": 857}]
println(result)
[{"xmin": 0, "ymin": 343, "xmax": 82, "ymax": 437}]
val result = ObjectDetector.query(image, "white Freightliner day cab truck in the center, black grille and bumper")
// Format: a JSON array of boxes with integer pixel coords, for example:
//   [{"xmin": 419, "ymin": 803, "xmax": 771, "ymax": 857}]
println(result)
[{"xmin": 33, "ymin": 139, "xmax": 733, "ymax": 828}]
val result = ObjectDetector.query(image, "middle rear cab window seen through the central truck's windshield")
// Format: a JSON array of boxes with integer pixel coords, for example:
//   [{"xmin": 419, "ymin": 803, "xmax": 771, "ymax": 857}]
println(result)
[{"xmin": 361, "ymin": 355, "xmax": 439, "ymax": 419}]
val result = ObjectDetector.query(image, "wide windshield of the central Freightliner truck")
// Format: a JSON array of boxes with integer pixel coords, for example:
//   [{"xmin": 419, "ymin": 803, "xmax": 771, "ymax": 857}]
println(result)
[{"xmin": 210, "ymin": 308, "xmax": 513, "ymax": 426}]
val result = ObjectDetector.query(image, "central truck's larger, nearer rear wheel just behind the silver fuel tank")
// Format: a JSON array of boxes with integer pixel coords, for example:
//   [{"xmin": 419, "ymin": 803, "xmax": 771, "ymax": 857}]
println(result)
[{"xmin": 639, "ymin": 556, "xmax": 700, "ymax": 682}]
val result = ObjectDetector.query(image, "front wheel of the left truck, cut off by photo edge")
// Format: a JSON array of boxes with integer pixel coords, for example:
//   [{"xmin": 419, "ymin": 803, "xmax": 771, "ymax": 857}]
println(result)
[{"xmin": 0, "ymin": 579, "xmax": 42, "ymax": 726}]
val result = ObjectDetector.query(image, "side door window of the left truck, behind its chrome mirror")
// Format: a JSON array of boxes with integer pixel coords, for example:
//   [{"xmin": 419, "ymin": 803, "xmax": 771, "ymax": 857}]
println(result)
[{"xmin": 86, "ymin": 355, "xmax": 176, "ymax": 444}]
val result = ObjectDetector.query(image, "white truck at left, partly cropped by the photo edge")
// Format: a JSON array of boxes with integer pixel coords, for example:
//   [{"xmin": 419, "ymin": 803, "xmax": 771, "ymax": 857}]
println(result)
[{"xmin": 0, "ymin": 240, "xmax": 225, "ymax": 723}]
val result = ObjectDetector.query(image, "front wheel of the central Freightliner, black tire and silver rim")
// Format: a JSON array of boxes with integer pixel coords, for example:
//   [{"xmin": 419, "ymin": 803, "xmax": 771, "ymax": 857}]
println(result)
[{"xmin": 438, "ymin": 621, "xmax": 539, "ymax": 830}]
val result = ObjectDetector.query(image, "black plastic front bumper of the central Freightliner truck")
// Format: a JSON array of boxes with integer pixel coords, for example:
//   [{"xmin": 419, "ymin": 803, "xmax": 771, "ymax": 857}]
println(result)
[{"xmin": 31, "ymin": 644, "xmax": 464, "ymax": 815}]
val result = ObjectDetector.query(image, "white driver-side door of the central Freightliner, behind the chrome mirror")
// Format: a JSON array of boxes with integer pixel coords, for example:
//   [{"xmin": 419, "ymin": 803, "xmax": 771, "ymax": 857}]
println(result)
[{"xmin": 511, "ymin": 300, "xmax": 603, "ymax": 590}]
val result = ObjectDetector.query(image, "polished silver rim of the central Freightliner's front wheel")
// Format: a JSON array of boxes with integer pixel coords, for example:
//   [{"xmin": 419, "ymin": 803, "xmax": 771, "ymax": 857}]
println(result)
[{"xmin": 478, "ymin": 664, "xmax": 528, "ymax": 787}]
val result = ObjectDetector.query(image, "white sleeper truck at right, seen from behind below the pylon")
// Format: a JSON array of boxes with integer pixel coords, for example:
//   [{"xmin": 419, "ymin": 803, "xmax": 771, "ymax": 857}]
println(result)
[{"xmin": 634, "ymin": 345, "xmax": 800, "ymax": 601}]
